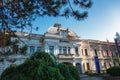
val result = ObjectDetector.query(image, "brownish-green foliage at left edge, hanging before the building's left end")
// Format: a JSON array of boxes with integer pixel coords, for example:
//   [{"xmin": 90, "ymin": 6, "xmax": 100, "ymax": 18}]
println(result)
[{"xmin": 0, "ymin": 32, "xmax": 27, "ymax": 57}]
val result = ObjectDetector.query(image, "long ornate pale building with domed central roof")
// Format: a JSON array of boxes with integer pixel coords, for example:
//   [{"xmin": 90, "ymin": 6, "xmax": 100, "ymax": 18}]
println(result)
[{"xmin": 0, "ymin": 23, "xmax": 120, "ymax": 73}]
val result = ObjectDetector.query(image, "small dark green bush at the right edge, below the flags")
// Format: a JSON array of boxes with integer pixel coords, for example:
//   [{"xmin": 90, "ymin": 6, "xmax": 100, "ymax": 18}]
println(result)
[{"xmin": 107, "ymin": 66, "xmax": 120, "ymax": 76}]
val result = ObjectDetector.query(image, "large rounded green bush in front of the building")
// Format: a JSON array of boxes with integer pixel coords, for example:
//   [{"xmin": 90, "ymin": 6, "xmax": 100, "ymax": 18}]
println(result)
[{"xmin": 0, "ymin": 52, "xmax": 80, "ymax": 80}]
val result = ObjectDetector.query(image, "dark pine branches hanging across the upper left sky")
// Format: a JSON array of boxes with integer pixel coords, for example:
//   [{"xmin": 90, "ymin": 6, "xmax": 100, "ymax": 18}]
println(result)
[{"xmin": 0, "ymin": 0, "xmax": 92, "ymax": 30}]
